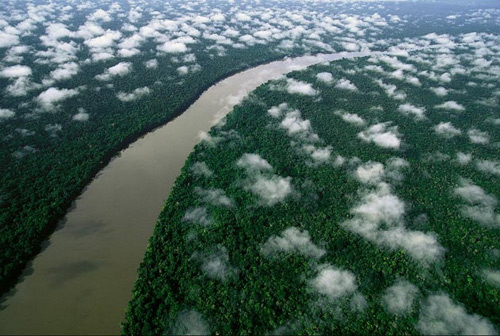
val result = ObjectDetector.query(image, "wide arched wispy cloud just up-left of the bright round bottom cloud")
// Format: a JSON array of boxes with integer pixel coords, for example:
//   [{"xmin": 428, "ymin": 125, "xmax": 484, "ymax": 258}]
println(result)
[{"xmin": 261, "ymin": 227, "xmax": 326, "ymax": 259}]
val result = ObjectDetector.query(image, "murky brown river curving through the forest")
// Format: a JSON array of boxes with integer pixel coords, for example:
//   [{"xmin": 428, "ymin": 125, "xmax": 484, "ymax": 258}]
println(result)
[{"xmin": 0, "ymin": 52, "xmax": 372, "ymax": 335}]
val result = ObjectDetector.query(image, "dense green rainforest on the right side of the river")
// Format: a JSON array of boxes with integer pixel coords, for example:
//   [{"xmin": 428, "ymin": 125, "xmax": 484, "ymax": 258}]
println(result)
[{"xmin": 123, "ymin": 38, "xmax": 500, "ymax": 335}]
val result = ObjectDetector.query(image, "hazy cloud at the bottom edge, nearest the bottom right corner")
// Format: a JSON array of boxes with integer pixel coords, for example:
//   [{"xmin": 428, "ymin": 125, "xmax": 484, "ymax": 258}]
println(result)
[{"xmin": 417, "ymin": 294, "xmax": 498, "ymax": 335}]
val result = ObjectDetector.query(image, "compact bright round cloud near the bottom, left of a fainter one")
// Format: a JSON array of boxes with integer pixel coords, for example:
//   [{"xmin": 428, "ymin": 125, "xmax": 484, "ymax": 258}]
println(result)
[{"xmin": 309, "ymin": 265, "xmax": 358, "ymax": 299}]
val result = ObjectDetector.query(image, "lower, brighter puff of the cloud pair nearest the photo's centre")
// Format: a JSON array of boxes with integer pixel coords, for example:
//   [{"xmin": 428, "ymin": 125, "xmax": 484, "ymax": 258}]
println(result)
[{"xmin": 248, "ymin": 175, "xmax": 293, "ymax": 206}]
